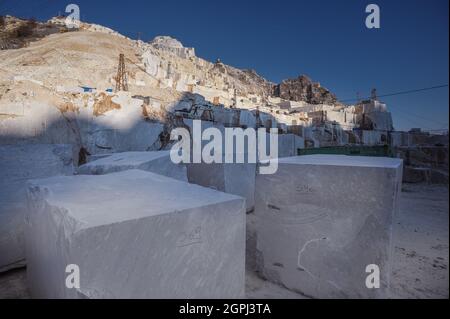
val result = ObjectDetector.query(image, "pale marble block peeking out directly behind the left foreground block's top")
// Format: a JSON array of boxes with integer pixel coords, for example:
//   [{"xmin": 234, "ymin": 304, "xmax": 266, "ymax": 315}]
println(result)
[{"xmin": 78, "ymin": 151, "xmax": 187, "ymax": 181}]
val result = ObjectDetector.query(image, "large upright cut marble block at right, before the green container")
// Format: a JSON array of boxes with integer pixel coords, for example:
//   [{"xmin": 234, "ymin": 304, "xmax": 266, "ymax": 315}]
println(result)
[{"xmin": 255, "ymin": 155, "xmax": 402, "ymax": 298}]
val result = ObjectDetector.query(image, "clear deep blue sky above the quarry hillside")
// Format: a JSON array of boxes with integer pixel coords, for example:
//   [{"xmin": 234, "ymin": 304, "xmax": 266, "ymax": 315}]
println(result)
[{"xmin": 0, "ymin": 0, "xmax": 449, "ymax": 130}]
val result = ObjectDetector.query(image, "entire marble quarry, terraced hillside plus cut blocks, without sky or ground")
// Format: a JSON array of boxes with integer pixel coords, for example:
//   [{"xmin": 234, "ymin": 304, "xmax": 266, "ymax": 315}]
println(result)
[{"xmin": 0, "ymin": 17, "xmax": 428, "ymax": 299}]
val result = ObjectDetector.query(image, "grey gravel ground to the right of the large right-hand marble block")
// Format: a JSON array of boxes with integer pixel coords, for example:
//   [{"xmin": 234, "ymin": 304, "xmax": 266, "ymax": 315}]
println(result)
[{"xmin": 392, "ymin": 184, "xmax": 449, "ymax": 298}]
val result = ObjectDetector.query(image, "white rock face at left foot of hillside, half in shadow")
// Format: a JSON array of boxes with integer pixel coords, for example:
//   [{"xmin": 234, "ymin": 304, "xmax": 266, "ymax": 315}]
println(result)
[{"xmin": 0, "ymin": 92, "xmax": 164, "ymax": 161}]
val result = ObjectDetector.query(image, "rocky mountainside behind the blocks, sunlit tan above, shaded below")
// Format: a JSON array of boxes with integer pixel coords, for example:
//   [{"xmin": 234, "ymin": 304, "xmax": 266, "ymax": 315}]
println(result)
[{"xmin": 0, "ymin": 16, "xmax": 358, "ymax": 164}]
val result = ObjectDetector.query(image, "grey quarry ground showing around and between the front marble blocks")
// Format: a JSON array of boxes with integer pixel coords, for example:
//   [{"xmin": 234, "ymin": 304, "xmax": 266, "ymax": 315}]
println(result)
[{"xmin": 0, "ymin": 184, "xmax": 449, "ymax": 298}]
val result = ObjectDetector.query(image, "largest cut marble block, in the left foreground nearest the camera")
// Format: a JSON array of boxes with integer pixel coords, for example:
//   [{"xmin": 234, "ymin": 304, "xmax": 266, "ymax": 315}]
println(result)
[{"xmin": 26, "ymin": 170, "xmax": 245, "ymax": 298}]
